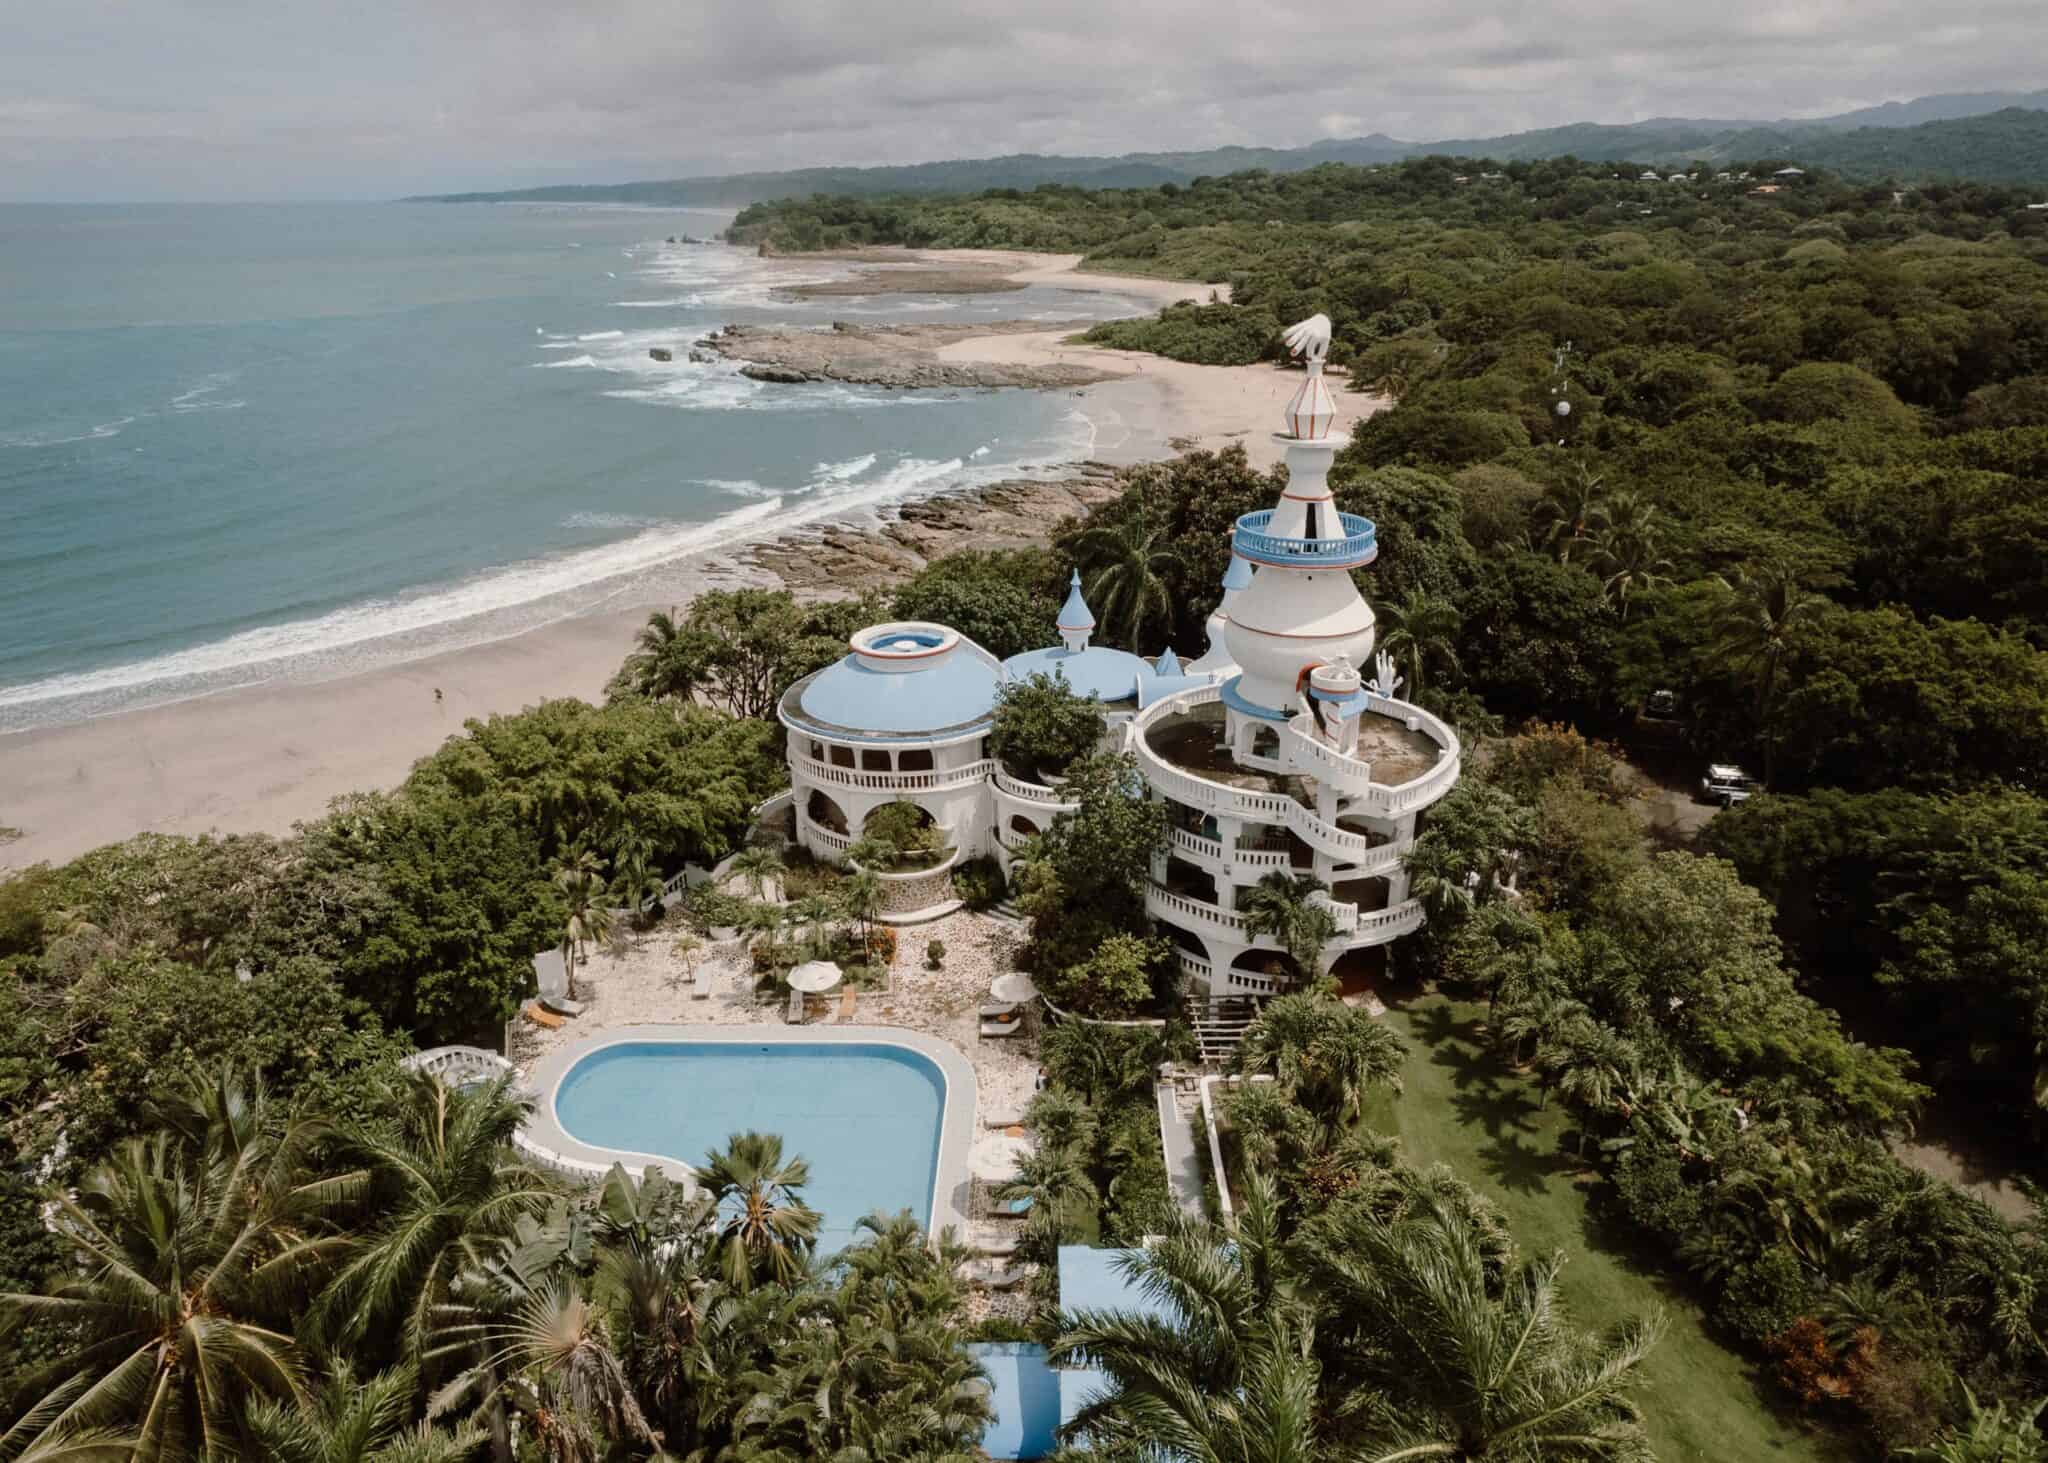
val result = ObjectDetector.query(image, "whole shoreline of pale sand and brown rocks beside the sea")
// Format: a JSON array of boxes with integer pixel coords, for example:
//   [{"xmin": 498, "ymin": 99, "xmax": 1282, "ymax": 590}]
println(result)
[{"xmin": 0, "ymin": 250, "xmax": 1372, "ymax": 873}]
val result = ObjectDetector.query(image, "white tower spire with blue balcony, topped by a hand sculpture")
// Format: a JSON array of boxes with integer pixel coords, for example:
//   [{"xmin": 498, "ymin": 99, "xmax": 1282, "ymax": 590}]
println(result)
[{"xmin": 1223, "ymin": 316, "xmax": 1378, "ymax": 725}]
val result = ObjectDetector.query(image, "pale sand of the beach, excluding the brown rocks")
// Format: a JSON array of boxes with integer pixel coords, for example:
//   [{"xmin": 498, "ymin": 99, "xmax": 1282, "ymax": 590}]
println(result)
[{"xmin": 0, "ymin": 250, "xmax": 1374, "ymax": 871}]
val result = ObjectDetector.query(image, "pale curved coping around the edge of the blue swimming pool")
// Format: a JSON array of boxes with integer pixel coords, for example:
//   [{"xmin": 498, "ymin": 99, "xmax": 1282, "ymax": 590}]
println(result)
[{"xmin": 514, "ymin": 1020, "xmax": 981, "ymax": 1240}]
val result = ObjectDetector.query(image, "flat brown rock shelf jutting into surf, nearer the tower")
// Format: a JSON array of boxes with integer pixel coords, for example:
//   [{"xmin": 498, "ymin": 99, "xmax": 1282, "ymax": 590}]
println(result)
[{"xmin": 696, "ymin": 320, "xmax": 1118, "ymax": 389}]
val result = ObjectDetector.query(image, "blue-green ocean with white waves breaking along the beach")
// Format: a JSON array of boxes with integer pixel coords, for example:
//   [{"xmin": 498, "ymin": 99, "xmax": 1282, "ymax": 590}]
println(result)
[{"xmin": 0, "ymin": 203, "xmax": 1147, "ymax": 732}]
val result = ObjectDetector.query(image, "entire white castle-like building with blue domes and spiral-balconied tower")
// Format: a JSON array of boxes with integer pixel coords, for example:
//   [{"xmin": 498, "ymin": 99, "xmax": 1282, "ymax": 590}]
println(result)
[{"xmin": 780, "ymin": 316, "xmax": 1458, "ymax": 998}]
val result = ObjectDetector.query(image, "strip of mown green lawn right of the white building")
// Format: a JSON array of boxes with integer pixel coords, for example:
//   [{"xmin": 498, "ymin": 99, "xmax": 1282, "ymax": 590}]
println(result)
[{"xmin": 1366, "ymin": 996, "xmax": 1845, "ymax": 1463}]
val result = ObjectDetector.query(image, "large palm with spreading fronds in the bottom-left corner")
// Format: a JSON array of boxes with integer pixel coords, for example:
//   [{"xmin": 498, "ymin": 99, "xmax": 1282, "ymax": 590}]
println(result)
[{"xmin": 0, "ymin": 1080, "xmax": 362, "ymax": 1461}]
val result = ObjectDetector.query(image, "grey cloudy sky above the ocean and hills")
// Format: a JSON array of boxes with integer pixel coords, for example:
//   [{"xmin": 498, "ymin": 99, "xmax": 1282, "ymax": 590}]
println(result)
[{"xmin": 0, "ymin": 0, "xmax": 2044, "ymax": 199}]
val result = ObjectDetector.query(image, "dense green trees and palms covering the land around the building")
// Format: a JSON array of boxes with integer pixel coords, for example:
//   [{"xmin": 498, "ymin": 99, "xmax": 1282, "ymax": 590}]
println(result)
[{"xmin": 0, "ymin": 145, "xmax": 2048, "ymax": 1459}]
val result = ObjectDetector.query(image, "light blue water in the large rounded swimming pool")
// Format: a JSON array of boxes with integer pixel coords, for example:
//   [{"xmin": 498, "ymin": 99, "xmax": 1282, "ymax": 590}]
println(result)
[{"xmin": 555, "ymin": 1041, "xmax": 946, "ymax": 1252}]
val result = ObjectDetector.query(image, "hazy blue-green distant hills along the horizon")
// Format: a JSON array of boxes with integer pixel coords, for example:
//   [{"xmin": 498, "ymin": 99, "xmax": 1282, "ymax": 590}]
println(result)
[{"xmin": 410, "ymin": 90, "xmax": 2048, "ymax": 207}]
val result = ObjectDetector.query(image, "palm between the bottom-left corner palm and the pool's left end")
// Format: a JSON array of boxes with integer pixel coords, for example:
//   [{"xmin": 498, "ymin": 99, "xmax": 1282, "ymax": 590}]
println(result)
[{"xmin": 311, "ymin": 1072, "xmax": 549, "ymax": 1356}]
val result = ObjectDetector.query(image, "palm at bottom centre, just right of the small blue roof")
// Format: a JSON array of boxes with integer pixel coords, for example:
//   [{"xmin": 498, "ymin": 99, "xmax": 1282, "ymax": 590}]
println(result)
[{"xmin": 1051, "ymin": 1168, "xmax": 1327, "ymax": 1463}]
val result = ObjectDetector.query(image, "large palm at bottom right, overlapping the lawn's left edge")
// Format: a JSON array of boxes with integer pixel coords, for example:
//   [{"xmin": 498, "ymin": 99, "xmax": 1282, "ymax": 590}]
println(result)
[{"xmin": 1303, "ymin": 1193, "xmax": 1663, "ymax": 1463}]
